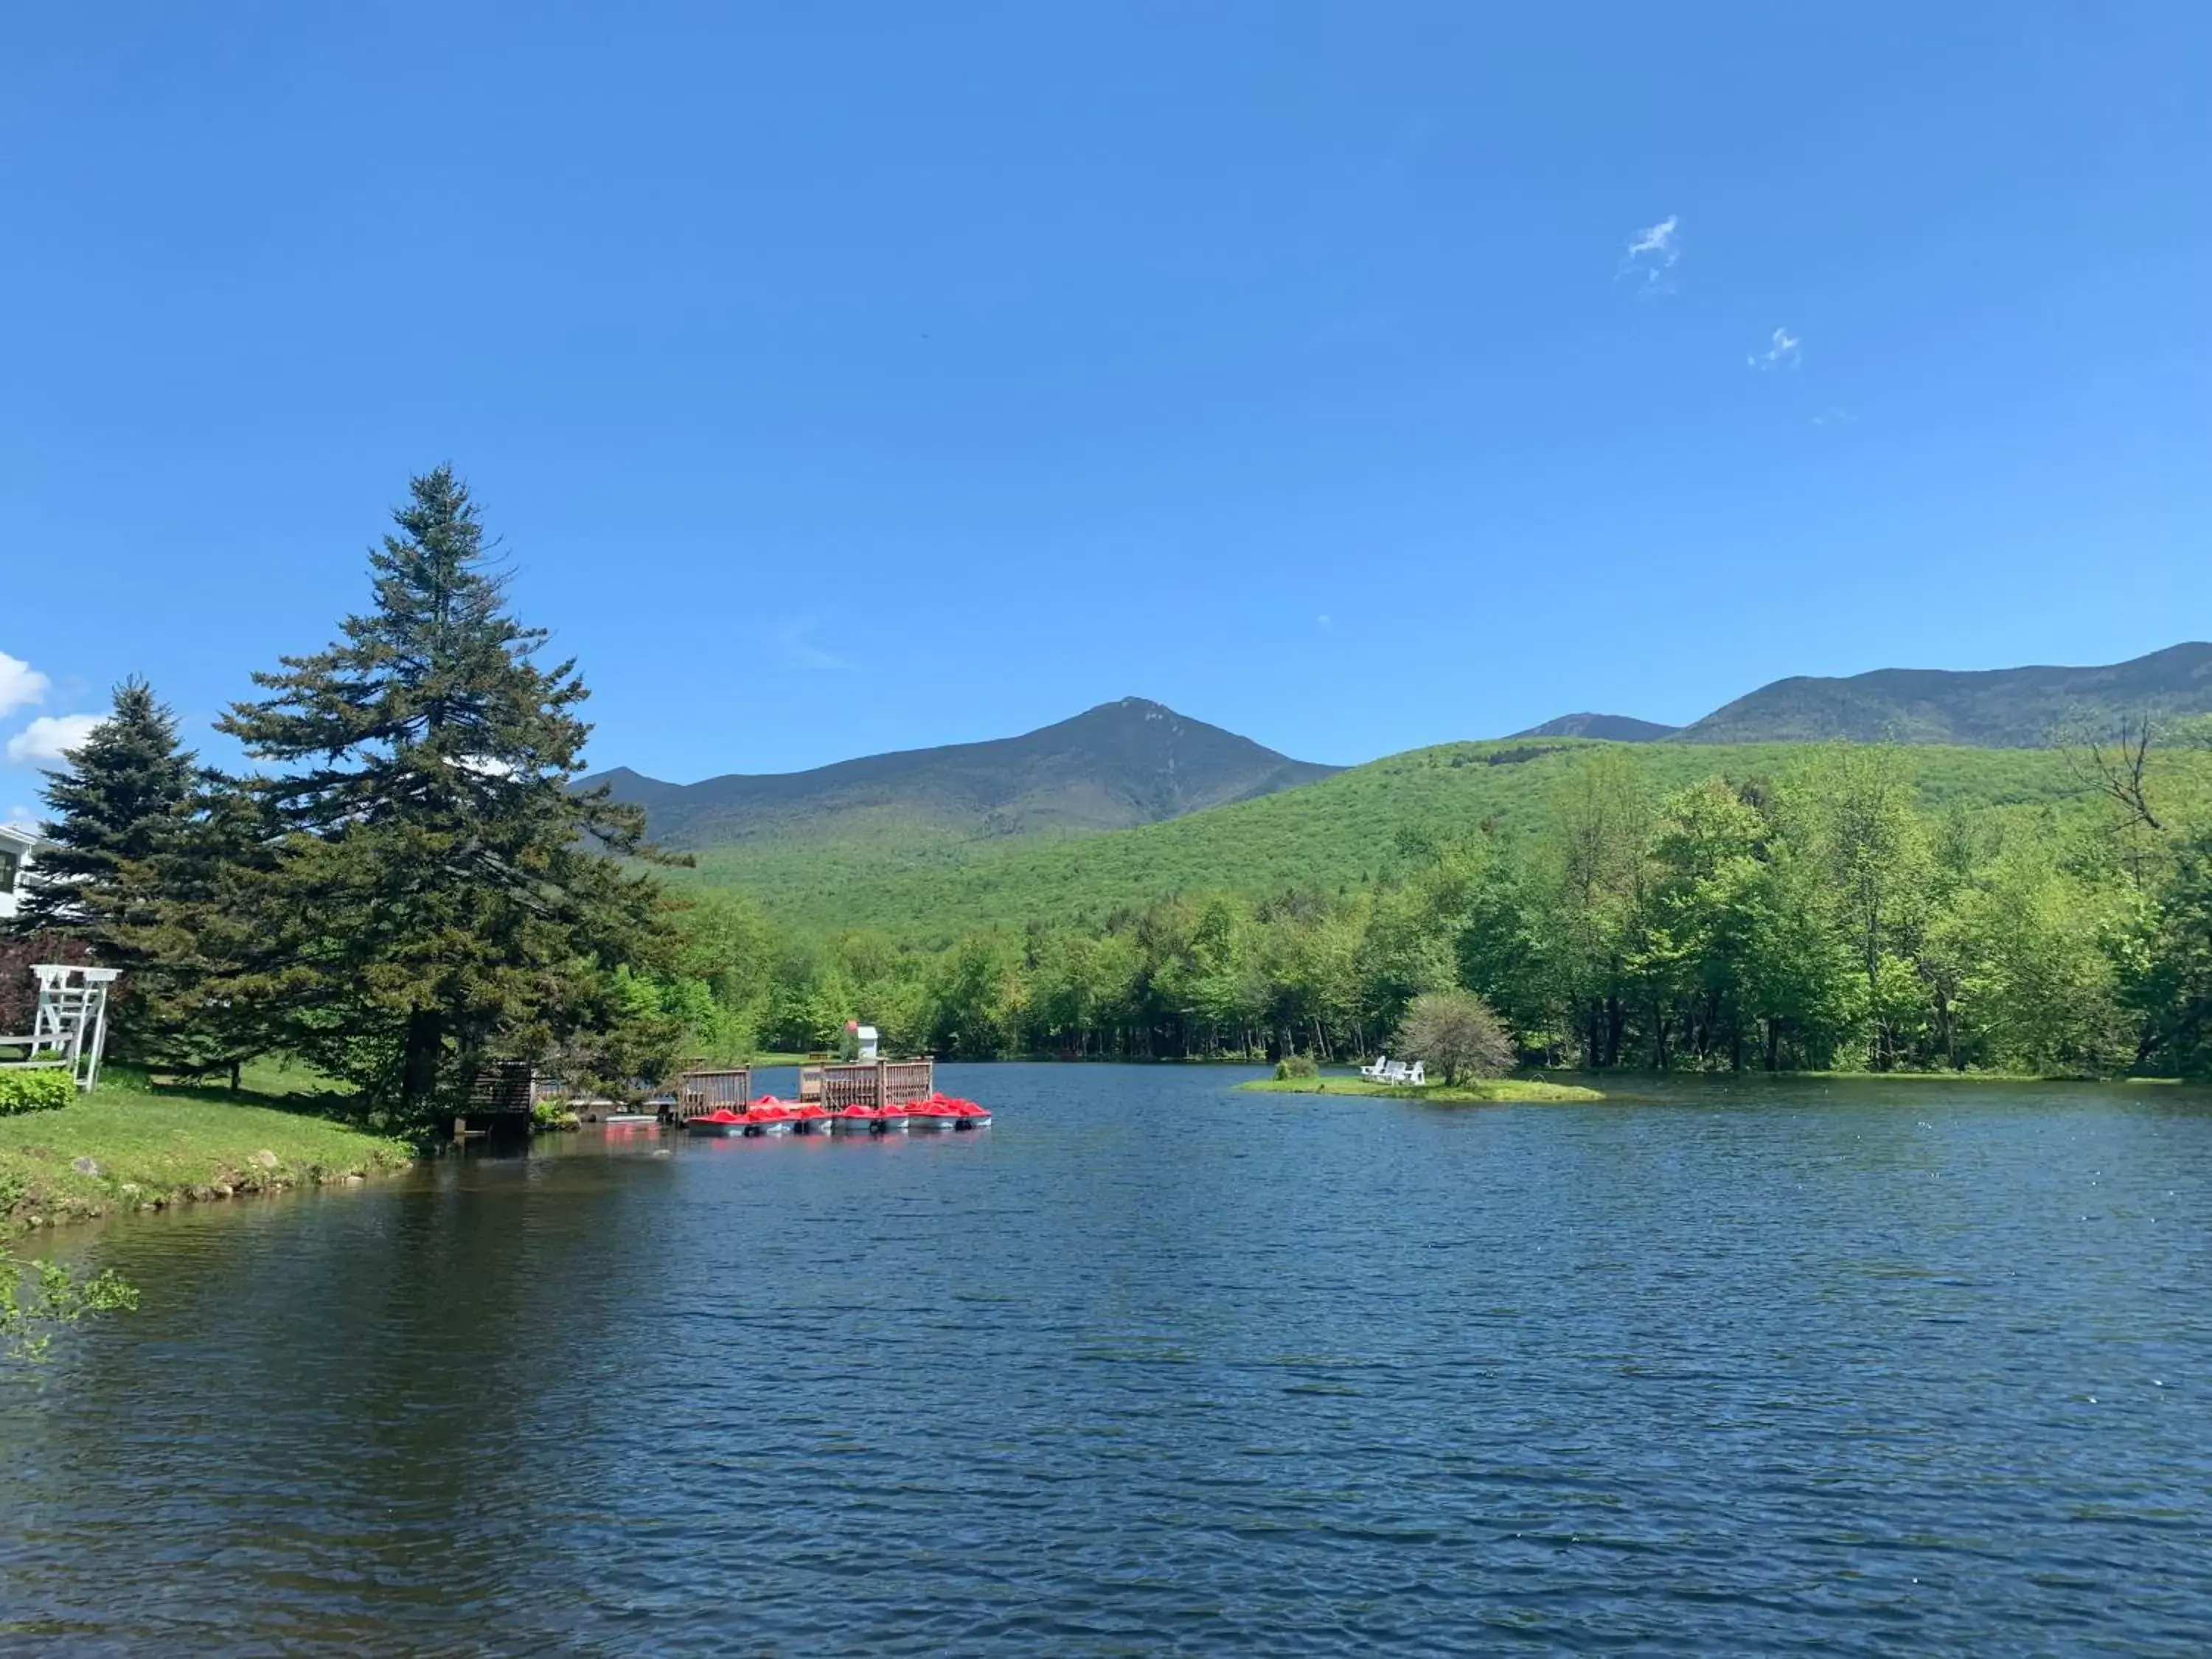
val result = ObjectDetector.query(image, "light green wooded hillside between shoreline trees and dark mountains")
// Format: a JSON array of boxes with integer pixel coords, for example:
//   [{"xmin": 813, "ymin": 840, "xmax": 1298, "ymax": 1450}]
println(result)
[{"xmin": 672, "ymin": 739, "xmax": 2124, "ymax": 945}]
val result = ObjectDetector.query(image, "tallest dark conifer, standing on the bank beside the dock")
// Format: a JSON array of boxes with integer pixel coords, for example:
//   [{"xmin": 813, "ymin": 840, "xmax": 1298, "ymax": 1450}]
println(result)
[{"xmin": 219, "ymin": 467, "xmax": 670, "ymax": 1117}]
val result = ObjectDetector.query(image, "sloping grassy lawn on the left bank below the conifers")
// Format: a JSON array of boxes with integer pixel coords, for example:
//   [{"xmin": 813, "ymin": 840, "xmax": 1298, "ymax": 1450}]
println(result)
[{"xmin": 0, "ymin": 1066, "xmax": 414, "ymax": 1234}]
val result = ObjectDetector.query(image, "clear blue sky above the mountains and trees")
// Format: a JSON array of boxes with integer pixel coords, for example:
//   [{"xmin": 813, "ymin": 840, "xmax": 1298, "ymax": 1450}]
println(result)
[{"xmin": 0, "ymin": 0, "xmax": 2212, "ymax": 810}]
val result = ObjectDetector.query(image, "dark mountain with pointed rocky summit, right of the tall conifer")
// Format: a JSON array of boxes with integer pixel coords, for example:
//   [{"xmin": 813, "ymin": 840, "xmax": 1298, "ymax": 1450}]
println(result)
[{"xmin": 580, "ymin": 697, "xmax": 1338, "ymax": 847}]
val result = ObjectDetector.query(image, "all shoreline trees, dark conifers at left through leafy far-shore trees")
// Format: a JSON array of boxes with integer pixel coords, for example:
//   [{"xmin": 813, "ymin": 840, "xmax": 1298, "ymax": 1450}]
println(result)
[{"xmin": 0, "ymin": 469, "xmax": 2212, "ymax": 1194}]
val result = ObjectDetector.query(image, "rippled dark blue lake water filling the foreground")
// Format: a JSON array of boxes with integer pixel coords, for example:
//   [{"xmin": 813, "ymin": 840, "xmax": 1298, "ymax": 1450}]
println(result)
[{"xmin": 0, "ymin": 1066, "xmax": 2212, "ymax": 1655}]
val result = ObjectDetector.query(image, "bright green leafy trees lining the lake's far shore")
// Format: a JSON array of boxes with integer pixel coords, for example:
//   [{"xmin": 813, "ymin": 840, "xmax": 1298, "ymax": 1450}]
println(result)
[{"xmin": 633, "ymin": 728, "xmax": 2212, "ymax": 1077}]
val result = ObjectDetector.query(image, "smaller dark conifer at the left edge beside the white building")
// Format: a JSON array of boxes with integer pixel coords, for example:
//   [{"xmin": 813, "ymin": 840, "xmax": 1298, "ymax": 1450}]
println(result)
[{"xmin": 18, "ymin": 679, "xmax": 197, "ymax": 947}]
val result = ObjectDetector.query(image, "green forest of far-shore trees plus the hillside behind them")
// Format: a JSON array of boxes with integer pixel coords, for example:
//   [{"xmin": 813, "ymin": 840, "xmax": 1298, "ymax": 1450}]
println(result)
[{"xmin": 633, "ymin": 737, "xmax": 2212, "ymax": 1073}]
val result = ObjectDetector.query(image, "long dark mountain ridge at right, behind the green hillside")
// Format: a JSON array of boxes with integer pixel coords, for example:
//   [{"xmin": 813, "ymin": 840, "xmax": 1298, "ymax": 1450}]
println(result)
[{"xmin": 1670, "ymin": 641, "xmax": 2212, "ymax": 748}]
